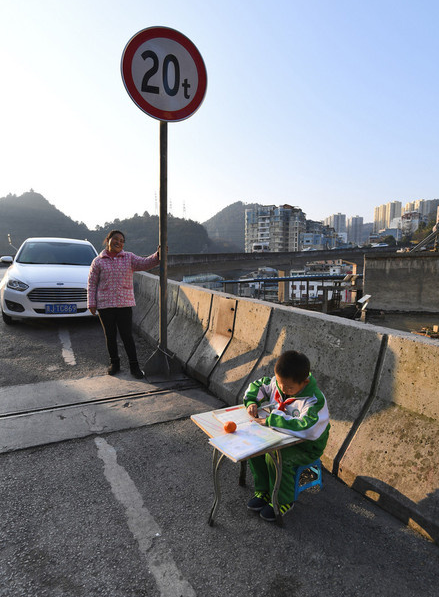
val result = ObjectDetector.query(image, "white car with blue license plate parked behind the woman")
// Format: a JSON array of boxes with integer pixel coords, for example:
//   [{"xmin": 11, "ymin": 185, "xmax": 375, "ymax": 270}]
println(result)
[{"xmin": 0, "ymin": 238, "xmax": 97, "ymax": 324}]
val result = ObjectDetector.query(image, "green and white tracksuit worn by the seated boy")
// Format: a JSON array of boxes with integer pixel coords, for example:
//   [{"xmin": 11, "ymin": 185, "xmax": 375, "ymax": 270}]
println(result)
[{"xmin": 244, "ymin": 374, "xmax": 330, "ymax": 506}]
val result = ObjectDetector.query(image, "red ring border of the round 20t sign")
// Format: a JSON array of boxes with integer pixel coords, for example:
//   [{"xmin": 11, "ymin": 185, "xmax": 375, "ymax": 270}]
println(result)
[{"xmin": 121, "ymin": 27, "xmax": 207, "ymax": 122}]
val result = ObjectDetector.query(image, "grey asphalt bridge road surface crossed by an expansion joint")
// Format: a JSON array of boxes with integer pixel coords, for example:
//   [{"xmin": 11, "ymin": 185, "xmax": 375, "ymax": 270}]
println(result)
[{"xmin": 0, "ymin": 304, "xmax": 439, "ymax": 597}]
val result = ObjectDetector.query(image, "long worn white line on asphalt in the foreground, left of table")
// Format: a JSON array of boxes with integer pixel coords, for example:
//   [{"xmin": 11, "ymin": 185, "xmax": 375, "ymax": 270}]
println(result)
[{"xmin": 95, "ymin": 437, "xmax": 196, "ymax": 597}]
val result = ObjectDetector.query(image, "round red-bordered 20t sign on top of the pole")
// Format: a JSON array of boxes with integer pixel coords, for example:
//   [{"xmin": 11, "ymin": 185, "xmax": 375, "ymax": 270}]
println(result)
[{"xmin": 121, "ymin": 27, "xmax": 207, "ymax": 122}]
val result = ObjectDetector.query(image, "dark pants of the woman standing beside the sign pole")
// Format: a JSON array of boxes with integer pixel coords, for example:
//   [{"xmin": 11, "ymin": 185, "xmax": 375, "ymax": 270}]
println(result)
[{"xmin": 99, "ymin": 307, "xmax": 137, "ymax": 365}]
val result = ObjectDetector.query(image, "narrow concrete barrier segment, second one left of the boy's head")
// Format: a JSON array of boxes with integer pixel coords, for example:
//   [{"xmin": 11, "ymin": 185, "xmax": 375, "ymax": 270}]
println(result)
[{"xmin": 187, "ymin": 292, "xmax": 237, "ymax": 385}]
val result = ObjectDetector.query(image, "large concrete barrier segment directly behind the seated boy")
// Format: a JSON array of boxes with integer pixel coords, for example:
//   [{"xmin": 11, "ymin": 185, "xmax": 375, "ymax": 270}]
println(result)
[{"xmin": 241, "ymin": 306, "xmax": 384, "ymax": 470}]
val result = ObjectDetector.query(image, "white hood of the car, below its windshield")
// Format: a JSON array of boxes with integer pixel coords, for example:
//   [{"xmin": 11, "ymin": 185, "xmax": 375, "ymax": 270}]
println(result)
[{"xmin": 6, "ymin": 263, "xmax": 90, "ymax": 286}]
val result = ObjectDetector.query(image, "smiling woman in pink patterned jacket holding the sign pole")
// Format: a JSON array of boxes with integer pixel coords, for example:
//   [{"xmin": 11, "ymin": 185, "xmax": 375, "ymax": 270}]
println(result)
[{"xmin": 87, "ymin": 230, "xmax": 160, "ymax": 379}]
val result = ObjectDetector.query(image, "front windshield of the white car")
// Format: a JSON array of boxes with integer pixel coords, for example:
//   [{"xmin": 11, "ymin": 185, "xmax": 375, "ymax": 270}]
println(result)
[{"xmin": 16, "ymin": 241, "xmax": 96, "ymax": 265}]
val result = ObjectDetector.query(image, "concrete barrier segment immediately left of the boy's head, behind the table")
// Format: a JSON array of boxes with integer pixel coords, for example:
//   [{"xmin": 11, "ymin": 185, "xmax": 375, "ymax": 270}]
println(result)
[{"xmin": 209, "ymin": 300, "xmax": 273, "ymax": 404}]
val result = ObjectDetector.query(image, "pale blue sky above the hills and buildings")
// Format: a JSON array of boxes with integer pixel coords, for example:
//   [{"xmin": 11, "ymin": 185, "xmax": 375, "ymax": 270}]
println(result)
[{"xmin": 0, "ymin": 0, "xmax": 439, "ymax": 227}]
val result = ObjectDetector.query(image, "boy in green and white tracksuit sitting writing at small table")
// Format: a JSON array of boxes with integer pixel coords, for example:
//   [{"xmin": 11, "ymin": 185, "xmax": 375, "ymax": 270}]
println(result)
[{"xmin": 244, "ymin": 350, "xmax": 330, "ymax": 522}]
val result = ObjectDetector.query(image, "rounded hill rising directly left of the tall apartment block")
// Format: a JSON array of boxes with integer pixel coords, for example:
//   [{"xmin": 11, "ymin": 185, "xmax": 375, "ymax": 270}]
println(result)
[{"xmin": 203, "ymin": 201, "xmax": 259, "ymax": 252}]
